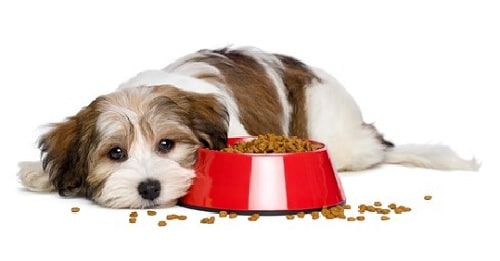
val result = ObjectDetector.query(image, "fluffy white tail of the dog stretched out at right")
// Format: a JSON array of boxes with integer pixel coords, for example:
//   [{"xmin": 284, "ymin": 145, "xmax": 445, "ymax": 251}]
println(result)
[{"xmin": 384, "ymin": 144, "xmax": 481, "ymax": 171}]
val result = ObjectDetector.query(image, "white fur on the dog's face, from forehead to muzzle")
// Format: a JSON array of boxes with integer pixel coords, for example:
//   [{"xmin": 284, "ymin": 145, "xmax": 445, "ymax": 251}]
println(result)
[{"xmin": 95, "ymin": 91, "xmax": 195, "ymax": 208}]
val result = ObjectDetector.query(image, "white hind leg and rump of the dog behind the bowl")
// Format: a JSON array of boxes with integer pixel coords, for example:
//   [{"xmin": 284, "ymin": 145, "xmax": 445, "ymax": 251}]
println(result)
[{"xmin": 305, "ymin": 69, "xmax": 392, "ymax": 171}]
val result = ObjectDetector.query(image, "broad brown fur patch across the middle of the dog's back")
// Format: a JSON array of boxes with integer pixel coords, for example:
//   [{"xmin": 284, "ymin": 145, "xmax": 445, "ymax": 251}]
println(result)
[{"xmin": 188, "ymin": 49, "xmax": 284, "ymax": 135}]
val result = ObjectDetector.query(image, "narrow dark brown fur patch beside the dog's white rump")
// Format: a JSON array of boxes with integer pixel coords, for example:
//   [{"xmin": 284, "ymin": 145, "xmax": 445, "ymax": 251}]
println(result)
[{"xmin": 276, "ymin": 54, "xmax": 321, "ymax": 138}]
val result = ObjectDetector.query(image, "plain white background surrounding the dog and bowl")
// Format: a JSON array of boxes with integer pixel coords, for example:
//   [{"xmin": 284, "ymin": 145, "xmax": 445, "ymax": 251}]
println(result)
[{"xmin": 0, "ymin": 0, "xmax": 500, "ymax": 260}]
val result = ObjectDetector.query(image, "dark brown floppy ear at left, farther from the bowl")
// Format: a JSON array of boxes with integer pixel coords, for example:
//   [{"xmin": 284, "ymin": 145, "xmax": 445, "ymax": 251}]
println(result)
[{"xmin": 38, "ymin": 100, "xmax": 98, "ymax": 196}]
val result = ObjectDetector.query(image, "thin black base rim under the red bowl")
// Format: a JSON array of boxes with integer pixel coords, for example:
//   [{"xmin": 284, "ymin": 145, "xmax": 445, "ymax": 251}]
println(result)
[{"xmin": 177, "ymin": 201, "xmax": 345, "ymax": 216}]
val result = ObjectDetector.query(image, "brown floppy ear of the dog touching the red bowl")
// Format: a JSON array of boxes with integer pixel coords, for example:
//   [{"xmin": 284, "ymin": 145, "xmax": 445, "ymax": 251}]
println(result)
[{"xmin": 185, "ymin": 94, "xmax": 229, "ymax": 150}]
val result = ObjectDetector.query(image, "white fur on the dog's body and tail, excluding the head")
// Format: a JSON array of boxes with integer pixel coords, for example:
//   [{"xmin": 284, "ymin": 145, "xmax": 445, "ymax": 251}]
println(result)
[{"xmin": 114, "ymin": 47, "xmax": 479, "ymax": 171}]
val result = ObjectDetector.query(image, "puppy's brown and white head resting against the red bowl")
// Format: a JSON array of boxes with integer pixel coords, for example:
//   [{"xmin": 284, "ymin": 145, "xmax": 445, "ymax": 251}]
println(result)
[{"xmin": 39, "ymin": 85, "xmax": 229, "ymax": 208}]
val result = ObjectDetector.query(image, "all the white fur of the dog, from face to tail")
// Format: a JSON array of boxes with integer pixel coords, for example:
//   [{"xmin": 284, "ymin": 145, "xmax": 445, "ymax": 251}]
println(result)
[{"xmin": 18, "ymin": 48, "xmax": 480, "ymax": 208}]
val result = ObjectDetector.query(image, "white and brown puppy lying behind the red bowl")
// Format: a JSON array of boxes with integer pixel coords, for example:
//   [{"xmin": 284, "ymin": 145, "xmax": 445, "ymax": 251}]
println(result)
[{"xmin": 18, "ymin": 45, "xmax": 479, "ymax": 208}]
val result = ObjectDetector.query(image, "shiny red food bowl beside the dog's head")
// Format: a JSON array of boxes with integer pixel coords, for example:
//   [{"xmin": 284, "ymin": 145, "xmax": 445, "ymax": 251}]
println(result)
[{"xmin": 179, "ymin": 137, "xmax": 345, "ymax": 215}]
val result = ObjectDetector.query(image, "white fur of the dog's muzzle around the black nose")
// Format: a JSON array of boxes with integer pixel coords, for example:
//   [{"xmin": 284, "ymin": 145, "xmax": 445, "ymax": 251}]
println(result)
[{"xmin": 95, "ymin": 135, "xmax": 195, "ymax": 208}]
